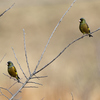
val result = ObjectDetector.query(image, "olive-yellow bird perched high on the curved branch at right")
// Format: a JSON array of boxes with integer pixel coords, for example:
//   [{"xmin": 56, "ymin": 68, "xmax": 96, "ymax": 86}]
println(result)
[{"xmin": 79, "ymin": 18, "xmax": 93, "ymax": 37}]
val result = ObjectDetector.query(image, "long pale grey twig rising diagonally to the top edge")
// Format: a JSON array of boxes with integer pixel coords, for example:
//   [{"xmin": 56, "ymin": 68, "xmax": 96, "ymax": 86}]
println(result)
[{"xmin": 33, "ymin": 0, "xmax": 76, "ymax": 73}]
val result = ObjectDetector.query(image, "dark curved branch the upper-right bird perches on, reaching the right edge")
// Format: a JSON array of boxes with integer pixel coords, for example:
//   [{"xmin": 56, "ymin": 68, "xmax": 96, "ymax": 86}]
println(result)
[{"xmin": 32, "ymin": 28, "xmax": 100, "ymax": 75}]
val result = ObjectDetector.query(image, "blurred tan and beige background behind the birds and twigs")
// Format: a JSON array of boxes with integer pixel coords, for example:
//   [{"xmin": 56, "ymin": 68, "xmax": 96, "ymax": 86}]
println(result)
[{"xmin": 0, "ymin": 0, "xmax": 100, "ymax": 100}]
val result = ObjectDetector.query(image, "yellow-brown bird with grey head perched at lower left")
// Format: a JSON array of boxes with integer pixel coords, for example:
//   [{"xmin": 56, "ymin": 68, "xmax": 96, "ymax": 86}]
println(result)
[{"xmin": 7, "ymin": 61, "xmax": 20, "ymax": 82}]
